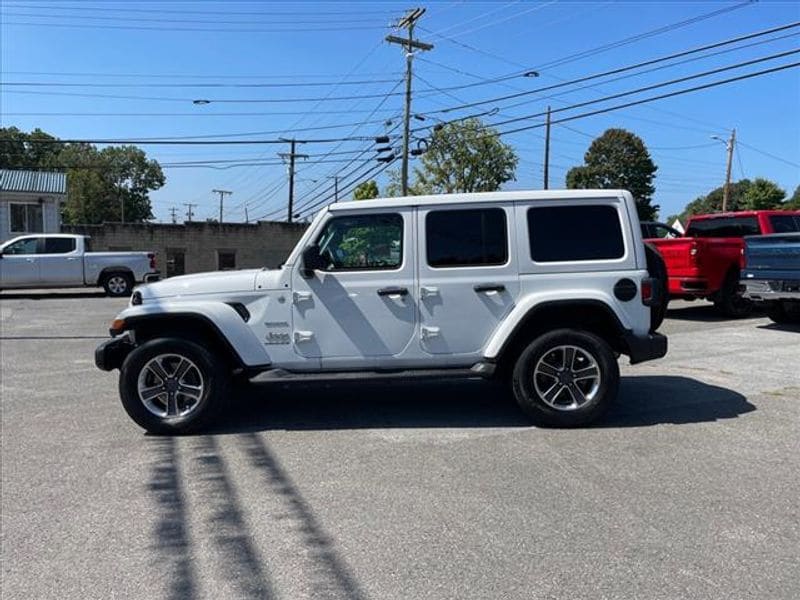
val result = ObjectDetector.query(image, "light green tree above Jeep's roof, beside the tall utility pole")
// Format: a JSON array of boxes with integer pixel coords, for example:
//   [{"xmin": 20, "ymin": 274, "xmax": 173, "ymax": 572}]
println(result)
[{"xmin": 398, "ymin": 118, "xmax": 519, "ymax": 195}]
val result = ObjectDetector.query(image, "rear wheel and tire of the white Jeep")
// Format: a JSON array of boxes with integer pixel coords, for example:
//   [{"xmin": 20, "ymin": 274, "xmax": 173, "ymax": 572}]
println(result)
[{"xmin": 511, "ymin": 329, "xmax": 619, "ymax": 427}]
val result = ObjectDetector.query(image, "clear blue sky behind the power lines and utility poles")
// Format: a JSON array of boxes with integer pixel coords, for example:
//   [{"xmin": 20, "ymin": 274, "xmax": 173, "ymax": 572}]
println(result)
[{"xmin": 0, "ymin": 0, "xmax": 800, "ymax": 221}]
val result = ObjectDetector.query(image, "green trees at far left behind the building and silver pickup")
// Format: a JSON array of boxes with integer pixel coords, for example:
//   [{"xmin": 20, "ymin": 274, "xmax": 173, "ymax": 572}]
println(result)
[{"xmin": 0, "ymin": 127, "xmax": 165, "ymax": 224}]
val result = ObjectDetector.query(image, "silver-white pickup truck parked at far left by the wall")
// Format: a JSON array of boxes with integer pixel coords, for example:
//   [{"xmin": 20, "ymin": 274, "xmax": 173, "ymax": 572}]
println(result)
[{"xmin": 0, "ymin": 234, "xmax": 159, "ymax": 296}]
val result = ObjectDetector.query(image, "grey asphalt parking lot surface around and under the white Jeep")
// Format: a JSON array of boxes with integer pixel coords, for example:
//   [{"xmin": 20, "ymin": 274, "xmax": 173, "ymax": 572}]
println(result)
[{"xmin": 0, "ymin": 291, "xmax": 800, "ymax": 600}]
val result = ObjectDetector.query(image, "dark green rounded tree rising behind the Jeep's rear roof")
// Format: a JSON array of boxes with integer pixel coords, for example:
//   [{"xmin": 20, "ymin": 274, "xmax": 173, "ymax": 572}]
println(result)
[{"xmin": 566, "ymin": 129, "xmax": 658, "ymax": 221}]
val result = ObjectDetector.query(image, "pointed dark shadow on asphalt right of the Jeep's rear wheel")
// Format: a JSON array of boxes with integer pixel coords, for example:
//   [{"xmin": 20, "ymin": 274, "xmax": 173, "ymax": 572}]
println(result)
[{"xmin": 595, "ymin": 376, "xmax": 756, "ymax": 427}]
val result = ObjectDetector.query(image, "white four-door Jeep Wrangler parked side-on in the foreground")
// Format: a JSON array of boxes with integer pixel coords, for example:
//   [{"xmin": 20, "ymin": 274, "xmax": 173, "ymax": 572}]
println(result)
[{"xmin": 95, "ymin": 190, "xmax": 667, "ymax": 433}]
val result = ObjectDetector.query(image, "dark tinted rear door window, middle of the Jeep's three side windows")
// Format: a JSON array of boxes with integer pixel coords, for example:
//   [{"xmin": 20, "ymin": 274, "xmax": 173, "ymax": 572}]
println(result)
[{"xmin": 425, "ymin": 208, "xmax": 508, "ymax": 267}]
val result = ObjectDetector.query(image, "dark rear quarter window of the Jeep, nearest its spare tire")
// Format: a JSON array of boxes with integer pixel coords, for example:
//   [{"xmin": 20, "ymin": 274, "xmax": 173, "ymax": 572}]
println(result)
[{"xmin": 528, "ymin": 205, "xmax": 625, "ymax": 263}]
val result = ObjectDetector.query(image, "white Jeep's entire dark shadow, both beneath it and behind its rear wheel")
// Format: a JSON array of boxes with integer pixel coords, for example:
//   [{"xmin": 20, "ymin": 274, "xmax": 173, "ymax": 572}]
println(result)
[{"xmin": 203, "ymin": 376, "xmax": 756, "ymax": 433}]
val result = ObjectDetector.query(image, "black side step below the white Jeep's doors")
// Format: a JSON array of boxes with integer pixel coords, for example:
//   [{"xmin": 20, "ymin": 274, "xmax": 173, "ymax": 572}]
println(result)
[{"xmin": 250, "ymin": 362, "xmax": 495, "ymax": 383}]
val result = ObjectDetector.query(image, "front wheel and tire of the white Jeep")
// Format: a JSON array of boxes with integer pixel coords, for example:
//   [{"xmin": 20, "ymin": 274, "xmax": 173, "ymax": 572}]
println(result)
[{"xmin": 119, "ymin": 338, "xmax": 229, "ymax": 434}]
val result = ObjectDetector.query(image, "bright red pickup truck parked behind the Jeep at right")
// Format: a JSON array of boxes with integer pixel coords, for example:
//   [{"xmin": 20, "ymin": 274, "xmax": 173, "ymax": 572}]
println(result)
[{"xmin": 645, "ymin": 210, "xmax": 800, "ymax": 317}]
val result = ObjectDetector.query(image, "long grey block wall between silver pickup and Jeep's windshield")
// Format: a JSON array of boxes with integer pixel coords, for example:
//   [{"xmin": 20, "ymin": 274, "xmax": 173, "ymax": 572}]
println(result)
[{"xmin": 61, "ymin": 222, "xmax": 306, "ymax": 276}]
